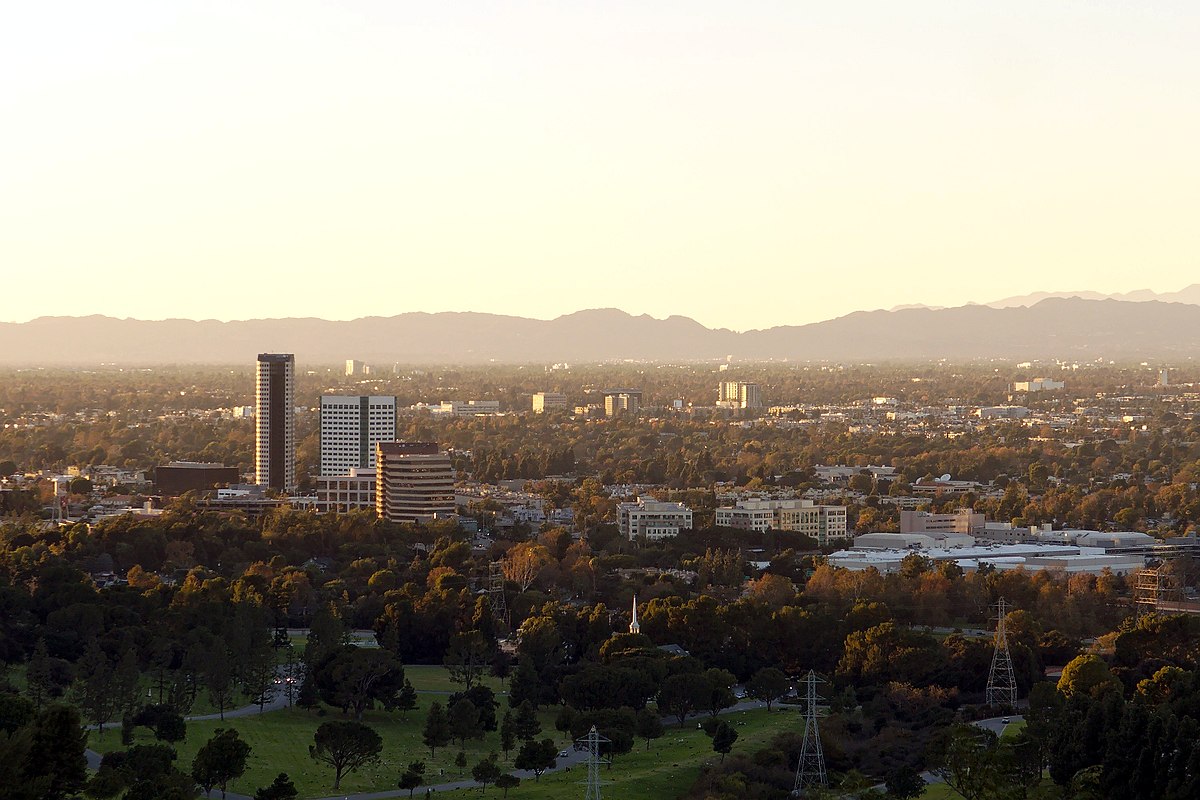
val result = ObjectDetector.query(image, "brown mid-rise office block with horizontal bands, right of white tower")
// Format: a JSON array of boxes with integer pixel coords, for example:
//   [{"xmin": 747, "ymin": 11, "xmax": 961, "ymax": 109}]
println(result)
[{"xmin": 376, "ymin": 441, "xmax": 454, "ymax": 522}]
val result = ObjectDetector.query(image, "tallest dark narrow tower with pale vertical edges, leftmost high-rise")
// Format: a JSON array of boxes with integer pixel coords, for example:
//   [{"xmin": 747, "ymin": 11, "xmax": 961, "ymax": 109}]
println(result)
[{"xmin": 254, "ymin": 353, "xmax": 296, "ymax": 492}]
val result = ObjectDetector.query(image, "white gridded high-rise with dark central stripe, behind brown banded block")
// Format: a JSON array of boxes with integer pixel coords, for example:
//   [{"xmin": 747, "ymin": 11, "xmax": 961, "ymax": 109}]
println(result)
[{"xmin": 320, "ymin": 395, "xmax": 396, "ymax": 476}]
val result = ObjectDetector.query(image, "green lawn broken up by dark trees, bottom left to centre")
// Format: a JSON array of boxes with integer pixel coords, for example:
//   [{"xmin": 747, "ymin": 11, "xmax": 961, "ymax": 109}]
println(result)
[{"xmin": 90, "ymin": 694, "xmax": 799, "ymax": 800}]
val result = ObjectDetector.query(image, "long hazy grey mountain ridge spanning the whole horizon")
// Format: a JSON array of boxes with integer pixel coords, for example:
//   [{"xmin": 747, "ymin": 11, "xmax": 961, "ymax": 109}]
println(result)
[{"xmin": 0, "ymin": 297, "xmax": 1200, "ymax": 366}]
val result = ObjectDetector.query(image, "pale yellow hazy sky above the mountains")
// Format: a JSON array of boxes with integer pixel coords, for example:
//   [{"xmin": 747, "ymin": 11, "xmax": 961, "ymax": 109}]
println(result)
[{"xmin": 0, "ymin": 0, "xmax": 1200, "ymax": 330}]
